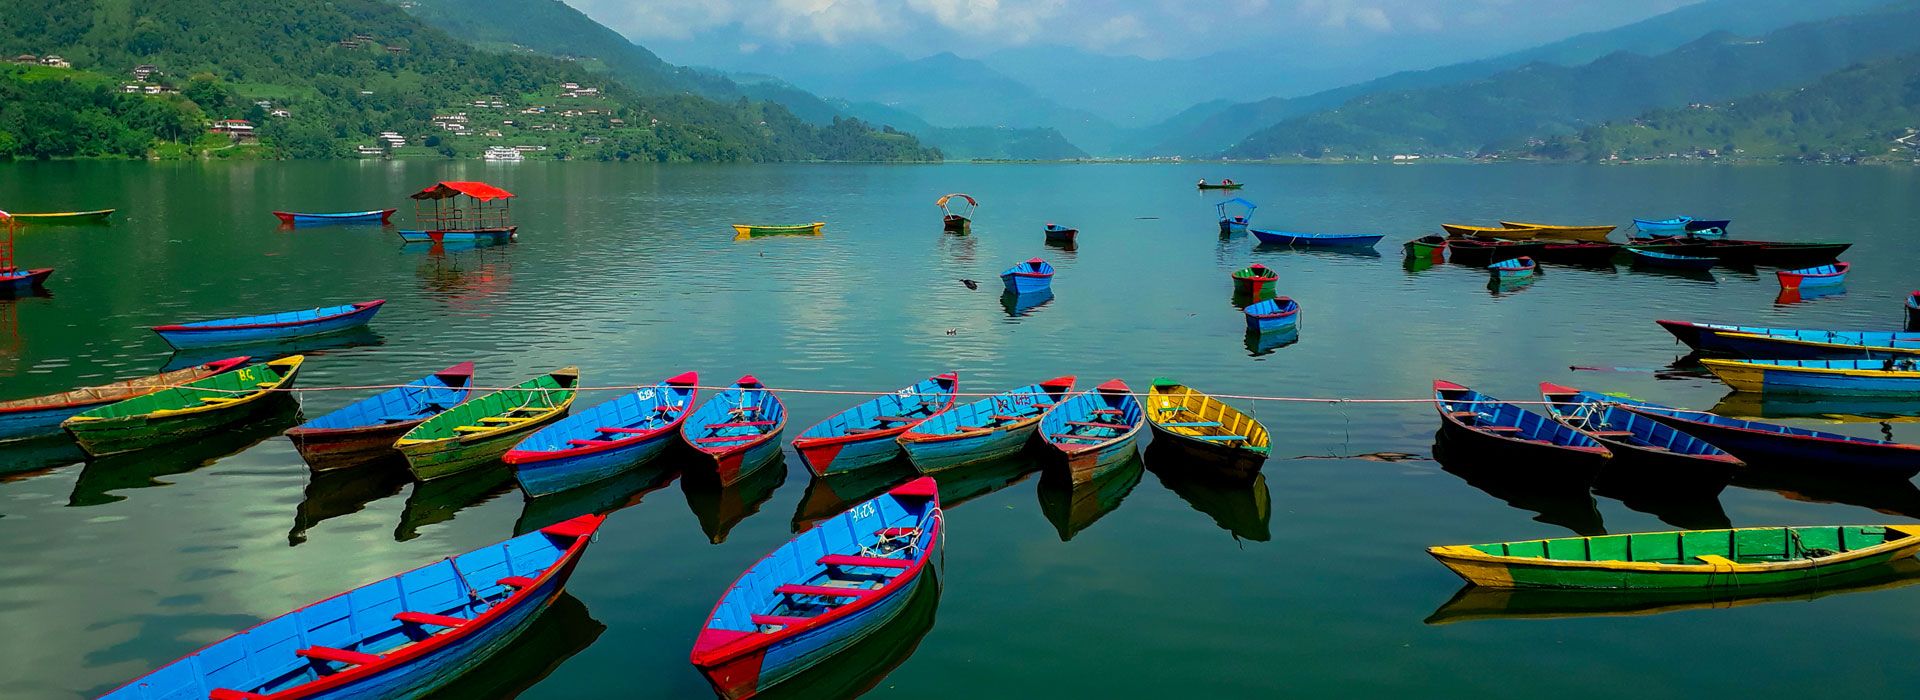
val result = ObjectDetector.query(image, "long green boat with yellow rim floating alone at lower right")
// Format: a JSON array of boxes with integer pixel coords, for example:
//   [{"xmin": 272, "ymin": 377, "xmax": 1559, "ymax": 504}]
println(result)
[{"xmin": 1427, "ymin": 525, "xmax": 1920, "ymax": 591}]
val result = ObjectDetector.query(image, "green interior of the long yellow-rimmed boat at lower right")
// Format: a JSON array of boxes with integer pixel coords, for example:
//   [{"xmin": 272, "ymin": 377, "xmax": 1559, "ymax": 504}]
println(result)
[{"xmin": 1473, "ymin": 525, "xmax": 1908, "ymax": 564}]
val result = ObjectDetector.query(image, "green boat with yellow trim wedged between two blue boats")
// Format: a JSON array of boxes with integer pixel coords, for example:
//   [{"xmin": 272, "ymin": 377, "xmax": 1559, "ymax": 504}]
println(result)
[{"xmin": 394, "ymin": 366, "xmax": 580, "ymax": 481}]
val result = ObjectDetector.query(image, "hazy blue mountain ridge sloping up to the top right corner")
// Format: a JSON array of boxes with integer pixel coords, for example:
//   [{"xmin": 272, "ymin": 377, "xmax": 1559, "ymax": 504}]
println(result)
[{"xmin": 1227, "ymin": 2, "xmax": 1920, "ymax": 157}]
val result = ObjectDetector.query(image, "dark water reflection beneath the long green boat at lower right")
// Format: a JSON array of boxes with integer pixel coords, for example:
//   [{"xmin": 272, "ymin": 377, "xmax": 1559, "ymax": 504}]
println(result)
[{"xmin": 1427, "ymin": 558, "xmax": 1920, "ymax": 625}]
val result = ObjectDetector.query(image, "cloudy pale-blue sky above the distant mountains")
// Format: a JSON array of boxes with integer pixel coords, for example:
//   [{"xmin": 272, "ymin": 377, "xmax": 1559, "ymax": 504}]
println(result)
[{"xmin": 566, "ymin": 0, "xmax": 1695, "ymax": 61}]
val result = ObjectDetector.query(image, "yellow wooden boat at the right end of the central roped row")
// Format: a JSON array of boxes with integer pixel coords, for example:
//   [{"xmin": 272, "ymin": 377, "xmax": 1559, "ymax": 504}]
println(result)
[{"xmin": 1146, "ymin": 378, "xmax": 1269, "ymax": 479}]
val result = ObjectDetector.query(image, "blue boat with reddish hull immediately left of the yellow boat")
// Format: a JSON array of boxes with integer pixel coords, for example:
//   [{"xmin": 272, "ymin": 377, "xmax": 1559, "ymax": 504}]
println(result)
[{"xmin": 1041, "ymin": 380, "xmax": 1146, "ymax": 483}]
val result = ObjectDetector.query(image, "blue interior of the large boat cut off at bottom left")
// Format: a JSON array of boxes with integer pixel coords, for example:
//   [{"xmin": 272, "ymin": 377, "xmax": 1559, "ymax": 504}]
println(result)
[{"xmin": 102, "ymin": 531, "xmax": 572, "ymax": 700}]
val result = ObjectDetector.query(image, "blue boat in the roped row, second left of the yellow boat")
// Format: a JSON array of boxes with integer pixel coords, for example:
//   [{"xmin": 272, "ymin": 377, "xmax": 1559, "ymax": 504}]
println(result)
[{"xmin": 897, "ymin": 376, "xmax": 1073, "ymax": 474}]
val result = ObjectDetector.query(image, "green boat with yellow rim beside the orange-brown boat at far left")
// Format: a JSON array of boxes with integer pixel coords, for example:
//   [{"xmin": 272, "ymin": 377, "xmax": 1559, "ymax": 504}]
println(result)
[{"xmin": 60, "ymin": 355, "xmax": 307, "ymax": 456}]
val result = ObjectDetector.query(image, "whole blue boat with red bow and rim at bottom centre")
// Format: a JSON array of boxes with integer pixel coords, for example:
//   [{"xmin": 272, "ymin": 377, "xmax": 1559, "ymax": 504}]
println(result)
[{"xmin": 691, "ymin": 478, "xmax": 947, "ymax": 700}]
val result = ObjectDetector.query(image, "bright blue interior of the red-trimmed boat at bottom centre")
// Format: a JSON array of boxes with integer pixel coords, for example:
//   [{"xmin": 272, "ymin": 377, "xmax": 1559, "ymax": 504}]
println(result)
[{"xmin": 707, "ymin": 493, "xmax": 933, "ymax": 633}]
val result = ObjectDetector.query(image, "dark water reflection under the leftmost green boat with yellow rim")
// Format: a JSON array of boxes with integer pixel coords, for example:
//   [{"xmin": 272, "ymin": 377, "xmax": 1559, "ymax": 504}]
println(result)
[{"xmin": 67, "ymin": 401, "xmax": 300, "ymax": 506}]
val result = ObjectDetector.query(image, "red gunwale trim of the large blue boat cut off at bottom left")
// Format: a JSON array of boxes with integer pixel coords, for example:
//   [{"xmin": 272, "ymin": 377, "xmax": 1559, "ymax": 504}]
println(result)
[{"xmin": 97, "ymin": 516, "xmax": 607, "ymax": 700}]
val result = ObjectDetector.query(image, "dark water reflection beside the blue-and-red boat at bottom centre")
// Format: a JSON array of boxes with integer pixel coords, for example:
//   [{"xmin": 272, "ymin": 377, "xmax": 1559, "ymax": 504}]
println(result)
[{"xmin": 756, "ymin": 568, "xmax": 941, "ymax": 700}]
